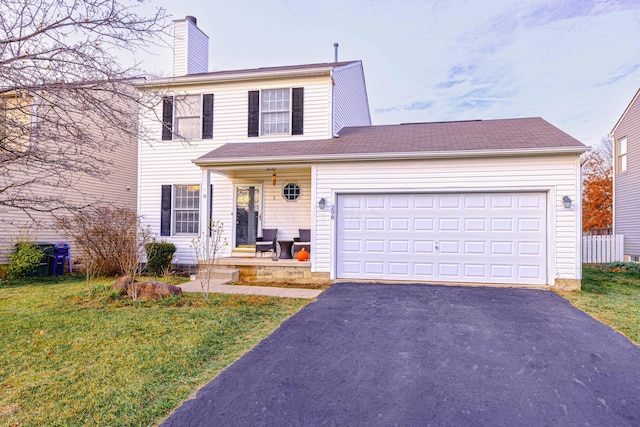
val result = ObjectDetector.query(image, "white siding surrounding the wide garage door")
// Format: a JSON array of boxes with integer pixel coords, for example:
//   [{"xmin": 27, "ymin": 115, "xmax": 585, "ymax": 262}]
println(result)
[{"xmin": 311, "ymin": 155, "xmax": 581, "ymax": 284}]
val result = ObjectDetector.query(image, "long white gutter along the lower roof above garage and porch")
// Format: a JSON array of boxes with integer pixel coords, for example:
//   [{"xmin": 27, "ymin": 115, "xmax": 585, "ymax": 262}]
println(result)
[{"xmin": 192, "ymin": 146, "xmax": 589, "ymax": 167}]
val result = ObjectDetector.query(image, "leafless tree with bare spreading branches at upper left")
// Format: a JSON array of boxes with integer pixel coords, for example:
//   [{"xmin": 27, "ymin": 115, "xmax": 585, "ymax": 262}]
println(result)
[{"xmin": 0, "ymin": 0, "xmax": 168, "ymax": 218}]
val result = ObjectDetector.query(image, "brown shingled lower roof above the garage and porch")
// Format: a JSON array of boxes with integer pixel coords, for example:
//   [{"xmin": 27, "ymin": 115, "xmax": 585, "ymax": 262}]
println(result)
[{"xmin": 194, "ymin": 117, "xmax": 588, "ymax": 165}]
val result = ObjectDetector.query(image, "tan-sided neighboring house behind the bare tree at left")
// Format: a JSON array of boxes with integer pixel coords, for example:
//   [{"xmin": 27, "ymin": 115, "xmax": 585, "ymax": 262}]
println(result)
[{"xmin": 0, "ymin": 82, "xmax": 138, "ymax": 264}]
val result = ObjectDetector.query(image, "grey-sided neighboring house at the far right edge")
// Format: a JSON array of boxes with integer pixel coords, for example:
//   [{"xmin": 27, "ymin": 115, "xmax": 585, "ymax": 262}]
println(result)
[{"xmin": 610, "ymin": 90, "xmax": 640, "ymax": 261}]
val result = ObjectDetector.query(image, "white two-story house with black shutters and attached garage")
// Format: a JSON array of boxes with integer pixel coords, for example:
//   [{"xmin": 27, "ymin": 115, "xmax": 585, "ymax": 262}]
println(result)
[{"xmin": 139, "ymin": 19, "xmax": 587, "ymax": 288}]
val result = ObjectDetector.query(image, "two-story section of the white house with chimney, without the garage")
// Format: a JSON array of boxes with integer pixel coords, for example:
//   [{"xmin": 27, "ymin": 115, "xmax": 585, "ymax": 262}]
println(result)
[{"xmin": 139, "ymin": 17, "xmax": 371, "ymax": 264}]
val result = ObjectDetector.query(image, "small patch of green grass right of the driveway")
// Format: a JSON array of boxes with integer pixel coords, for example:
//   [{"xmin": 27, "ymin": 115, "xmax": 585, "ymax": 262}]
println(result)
[{"xmin": 562, "ymin": 266, "xmax": 640, "ymax": 344}]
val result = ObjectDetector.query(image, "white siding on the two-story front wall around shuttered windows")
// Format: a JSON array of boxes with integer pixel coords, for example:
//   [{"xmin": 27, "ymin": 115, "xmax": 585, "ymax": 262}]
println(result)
[{"xmin": 138, "ymin": 75, "xmax": 331, "ymax": 264}]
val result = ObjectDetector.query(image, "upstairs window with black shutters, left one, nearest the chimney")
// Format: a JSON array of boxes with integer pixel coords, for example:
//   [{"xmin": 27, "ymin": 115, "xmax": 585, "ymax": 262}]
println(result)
[{"xmin": 162, "ymin": 94, "xmax": 213, "ymax": 140}]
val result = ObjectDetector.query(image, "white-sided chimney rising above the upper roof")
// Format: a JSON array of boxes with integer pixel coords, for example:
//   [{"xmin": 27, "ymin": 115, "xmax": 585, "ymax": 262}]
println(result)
[{"xmin": 173, "ymin": 16, "xmax": 209, "ymax": 77}]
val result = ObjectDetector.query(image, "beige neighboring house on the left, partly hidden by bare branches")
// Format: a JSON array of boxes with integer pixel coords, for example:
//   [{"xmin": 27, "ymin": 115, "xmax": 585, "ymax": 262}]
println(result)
[{"xmin": 0, "ymin": 89, "xmax": 138, "ymax": 264}]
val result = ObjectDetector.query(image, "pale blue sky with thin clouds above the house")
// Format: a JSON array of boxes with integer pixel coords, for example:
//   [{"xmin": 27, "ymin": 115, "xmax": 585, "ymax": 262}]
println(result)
[{"xmin": 134, "ymin": 0, "xmax": 640, "ymax": 145}]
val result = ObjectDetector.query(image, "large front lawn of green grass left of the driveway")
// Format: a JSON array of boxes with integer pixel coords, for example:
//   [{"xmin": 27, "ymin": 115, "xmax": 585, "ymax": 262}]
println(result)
[{"xmin": 0, "ymin": 278, "xmax": 308, "ymax": 426}]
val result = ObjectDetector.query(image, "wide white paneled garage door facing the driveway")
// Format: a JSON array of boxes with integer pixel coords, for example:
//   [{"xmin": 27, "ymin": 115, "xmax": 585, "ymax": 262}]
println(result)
[{"xmin": 336, "ymin": 193, "xmax": 547, "ymax": 284}]
